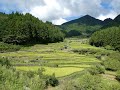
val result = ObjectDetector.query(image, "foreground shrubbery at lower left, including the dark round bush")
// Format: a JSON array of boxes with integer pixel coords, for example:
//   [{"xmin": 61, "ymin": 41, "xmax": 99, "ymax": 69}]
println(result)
[{"xmin": 0, "ymin": 58, "xmax": 58, "ymax": 90}]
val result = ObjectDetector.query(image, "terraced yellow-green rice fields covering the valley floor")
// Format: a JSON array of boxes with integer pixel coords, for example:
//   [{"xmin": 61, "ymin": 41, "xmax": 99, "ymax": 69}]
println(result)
[{"xmin": 0, "ymin": 38, "xmax": 104, "ymax": 77}]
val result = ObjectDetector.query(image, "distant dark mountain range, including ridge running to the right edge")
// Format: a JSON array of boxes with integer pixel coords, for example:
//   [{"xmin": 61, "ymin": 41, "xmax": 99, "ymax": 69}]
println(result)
[{"xmin": 60, "ymin": 15, "xmax": 120, "ymax": 37}]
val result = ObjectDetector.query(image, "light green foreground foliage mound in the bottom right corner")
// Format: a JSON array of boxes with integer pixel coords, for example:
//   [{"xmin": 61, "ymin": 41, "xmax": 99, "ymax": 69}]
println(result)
[{"xmin": 62, "ymin": 72, "xmax": 120, "ymax": 90}]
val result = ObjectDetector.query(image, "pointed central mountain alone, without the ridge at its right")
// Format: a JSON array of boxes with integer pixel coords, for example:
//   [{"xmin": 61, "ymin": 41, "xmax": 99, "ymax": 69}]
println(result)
[{"xmin": 60, "ymin": 15, "xmax": 103, "ymax": 37}]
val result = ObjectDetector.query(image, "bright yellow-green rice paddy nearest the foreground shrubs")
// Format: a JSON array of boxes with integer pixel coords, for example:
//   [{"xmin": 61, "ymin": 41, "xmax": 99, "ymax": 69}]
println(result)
[{"xmin": 16, "ymin": 66, "xmax": 84, "ymax": 77}]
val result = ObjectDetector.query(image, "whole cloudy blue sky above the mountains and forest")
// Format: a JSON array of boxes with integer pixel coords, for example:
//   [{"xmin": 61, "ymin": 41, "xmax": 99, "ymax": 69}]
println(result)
[{"xmin": 0, "ymin": 0, "xmax": 120, "ymax": 25}]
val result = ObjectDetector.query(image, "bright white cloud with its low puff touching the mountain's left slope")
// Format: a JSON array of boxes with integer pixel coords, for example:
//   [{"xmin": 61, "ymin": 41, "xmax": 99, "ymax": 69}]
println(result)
[{"xmin": 30, "ymin": 0, "xmax": 71, "ymax": 24}]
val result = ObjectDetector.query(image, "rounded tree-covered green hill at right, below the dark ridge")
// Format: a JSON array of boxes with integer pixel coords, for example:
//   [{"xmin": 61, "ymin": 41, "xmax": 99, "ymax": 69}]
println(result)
[{"xmin": 90, "ymin": 27, "xmax": 120, "ymax": 51}]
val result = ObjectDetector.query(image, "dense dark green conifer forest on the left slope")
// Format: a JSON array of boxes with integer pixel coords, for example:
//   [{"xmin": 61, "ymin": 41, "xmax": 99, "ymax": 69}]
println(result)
[{"xmin": 0, "ymin": 12, "xmax": 64, "ymax": 44}]
